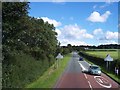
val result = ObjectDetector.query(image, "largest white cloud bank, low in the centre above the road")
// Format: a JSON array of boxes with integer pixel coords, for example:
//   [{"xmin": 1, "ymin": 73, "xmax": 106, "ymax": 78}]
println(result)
[{"xmin": 56, "ymin": 24, "xmax": 93, "ymax": 46}]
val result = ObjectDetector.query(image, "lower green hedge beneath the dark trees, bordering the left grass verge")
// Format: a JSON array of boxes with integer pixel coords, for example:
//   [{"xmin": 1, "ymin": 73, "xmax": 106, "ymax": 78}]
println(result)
[{"xmin": 2, "ymin": 51, "xmax": 54, "ymax": 88}]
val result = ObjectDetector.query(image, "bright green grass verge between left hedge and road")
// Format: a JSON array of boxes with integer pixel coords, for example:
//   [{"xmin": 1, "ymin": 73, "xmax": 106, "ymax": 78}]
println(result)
[{"xmin": 26, "ymin": 54, "xmax": 71, "ymax": 88}]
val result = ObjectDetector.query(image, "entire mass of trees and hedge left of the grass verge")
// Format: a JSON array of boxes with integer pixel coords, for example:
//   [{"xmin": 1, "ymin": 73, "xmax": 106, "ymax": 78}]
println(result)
[{"xmin": 2, "ymin": 2, "xmax": 63, "ymax": 88}]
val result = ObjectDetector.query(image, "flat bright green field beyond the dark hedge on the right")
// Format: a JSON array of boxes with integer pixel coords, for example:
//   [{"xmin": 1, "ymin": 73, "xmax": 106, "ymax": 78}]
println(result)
[{"xmin": 86, "ymin": 51, "xmax": 118, "ymax": 59}]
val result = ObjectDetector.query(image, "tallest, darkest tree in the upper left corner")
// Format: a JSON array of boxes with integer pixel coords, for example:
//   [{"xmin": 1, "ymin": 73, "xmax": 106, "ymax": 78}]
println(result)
[{"xmin": 2, "ymin": 2, "xmax": 29, "ymax": 50}]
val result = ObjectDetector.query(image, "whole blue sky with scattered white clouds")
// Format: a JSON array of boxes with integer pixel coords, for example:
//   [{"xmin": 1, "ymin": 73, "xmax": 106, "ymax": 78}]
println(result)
[{"xmin": 29, "ymin": 2, "xmax": 120, "ymax": 46}]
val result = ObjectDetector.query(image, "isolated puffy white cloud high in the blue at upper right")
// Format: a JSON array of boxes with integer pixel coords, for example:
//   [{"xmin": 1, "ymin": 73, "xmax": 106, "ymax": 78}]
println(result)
[{"xmin": 87, "ymin": 11, "xmax": 111, "ymax": 22}]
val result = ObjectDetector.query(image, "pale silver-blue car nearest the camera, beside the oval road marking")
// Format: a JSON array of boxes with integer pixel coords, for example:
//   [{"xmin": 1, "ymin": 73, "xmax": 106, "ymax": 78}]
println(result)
[{"xmin": 88, "ymin": 65, "xmax": 101, "ymax": 75}]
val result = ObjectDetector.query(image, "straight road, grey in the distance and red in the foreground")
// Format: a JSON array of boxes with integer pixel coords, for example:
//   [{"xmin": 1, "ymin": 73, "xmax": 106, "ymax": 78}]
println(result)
[{"xmin": 55, "ymin": 52, "xmax": 119, "ymax": 90}]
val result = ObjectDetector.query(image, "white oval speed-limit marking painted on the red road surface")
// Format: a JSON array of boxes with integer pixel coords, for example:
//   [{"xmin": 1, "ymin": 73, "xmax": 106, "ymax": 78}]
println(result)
[{"xmin": 94, "ymin": 76, "xmax": 112, "ymax": 88}]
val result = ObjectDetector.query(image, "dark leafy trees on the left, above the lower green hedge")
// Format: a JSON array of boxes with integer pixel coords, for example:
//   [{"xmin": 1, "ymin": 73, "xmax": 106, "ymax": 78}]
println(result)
[{"xmin": 2, "ymin": 2, "xmax": 57, "ymax": 61}]
